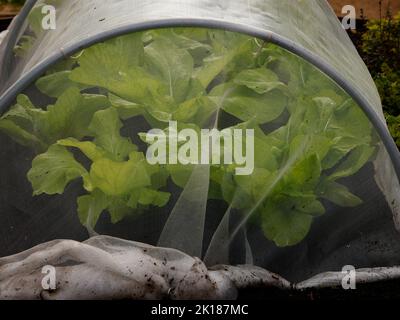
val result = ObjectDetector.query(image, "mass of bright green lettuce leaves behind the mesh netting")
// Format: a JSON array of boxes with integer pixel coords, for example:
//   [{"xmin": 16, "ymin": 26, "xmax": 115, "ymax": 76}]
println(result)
[{"xmin": 0, "ymin": 28, "xmax": 378, "ymax": 247}]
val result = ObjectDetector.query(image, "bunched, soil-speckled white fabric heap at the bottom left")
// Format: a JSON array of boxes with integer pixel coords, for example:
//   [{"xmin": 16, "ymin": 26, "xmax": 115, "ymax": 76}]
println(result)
[{"xmin": 0, "ymin": 236, "xmax": 290, "ymax": 300}]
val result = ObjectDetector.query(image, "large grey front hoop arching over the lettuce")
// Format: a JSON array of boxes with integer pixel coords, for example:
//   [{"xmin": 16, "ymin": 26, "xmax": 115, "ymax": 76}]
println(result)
[{"xmin": 0, "ymin": 18, "xmax": 400, "ymax": 181}]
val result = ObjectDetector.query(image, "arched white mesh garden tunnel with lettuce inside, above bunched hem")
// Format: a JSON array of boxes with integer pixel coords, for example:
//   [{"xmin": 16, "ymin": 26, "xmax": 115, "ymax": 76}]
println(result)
[{"xmin": 0, "ymin": 0, "xmax": 400, "ymax": 281}]
